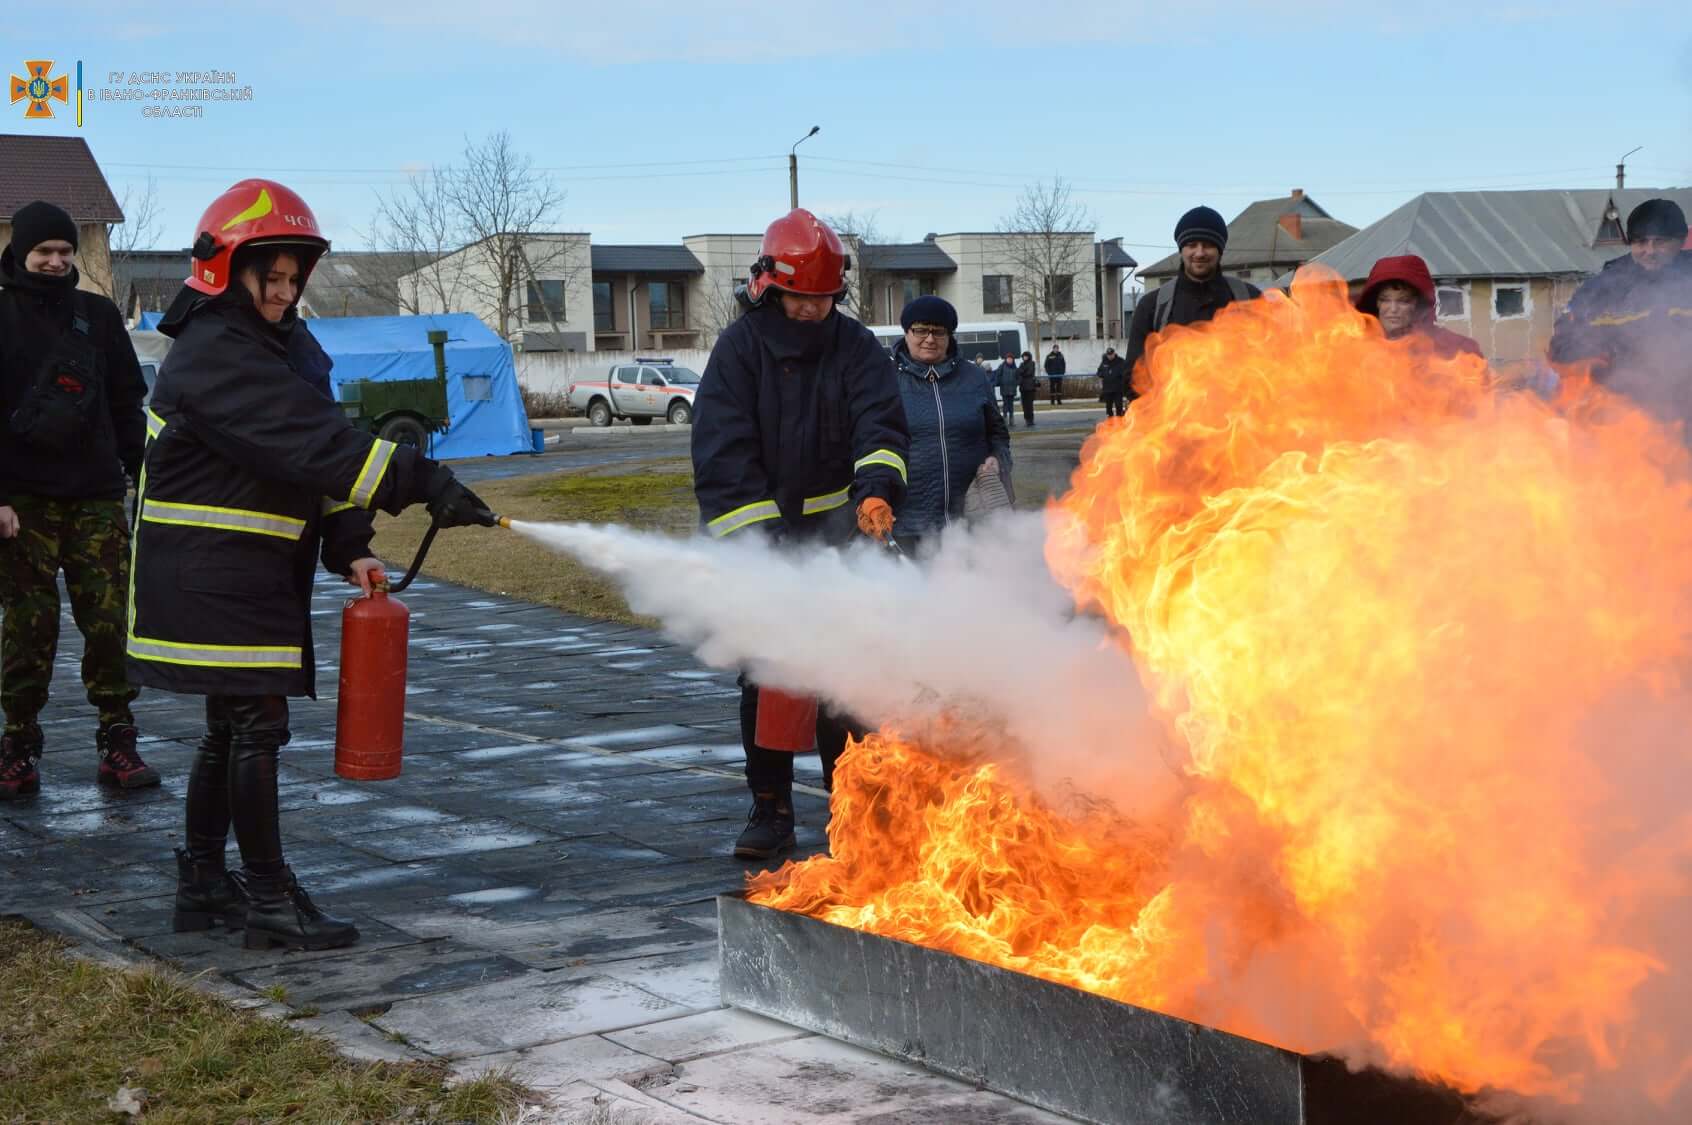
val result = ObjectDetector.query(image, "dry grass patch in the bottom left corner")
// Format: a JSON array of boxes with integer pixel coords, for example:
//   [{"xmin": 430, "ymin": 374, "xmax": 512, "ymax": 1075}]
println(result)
[{"xmin": 0, "ymin": 922, "xmax": 531, "ymax": 1125}]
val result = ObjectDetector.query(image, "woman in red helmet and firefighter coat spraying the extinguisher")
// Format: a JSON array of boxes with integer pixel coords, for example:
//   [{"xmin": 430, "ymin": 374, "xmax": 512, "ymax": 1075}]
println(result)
[{"xmin": 127, "ymin": 179, "xmax": 492, "ymax": 949}]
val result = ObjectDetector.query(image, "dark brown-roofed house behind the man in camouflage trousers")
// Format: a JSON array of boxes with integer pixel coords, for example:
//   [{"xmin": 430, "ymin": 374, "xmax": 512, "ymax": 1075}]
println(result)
[{"xmin": 0, "ymin": 134, "xmax": 124, "ymax": 296}]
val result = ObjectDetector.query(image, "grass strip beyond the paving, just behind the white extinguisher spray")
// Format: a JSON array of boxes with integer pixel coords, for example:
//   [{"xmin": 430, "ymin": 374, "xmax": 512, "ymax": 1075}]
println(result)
[{"xmin": 374, "ymin": 458, "xmax": 699, "ymax": 624}]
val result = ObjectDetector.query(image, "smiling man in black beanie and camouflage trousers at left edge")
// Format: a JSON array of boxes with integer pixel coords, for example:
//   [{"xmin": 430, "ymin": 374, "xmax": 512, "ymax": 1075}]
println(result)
[{"xmin": 0, "ymin": 201, "xmax": 159, "ymax": 800}]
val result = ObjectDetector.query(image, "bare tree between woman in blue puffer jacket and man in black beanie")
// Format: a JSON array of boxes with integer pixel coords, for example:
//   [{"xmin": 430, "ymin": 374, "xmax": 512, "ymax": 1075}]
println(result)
[{"xmin": 998, "ymin": 178, "xmax": 1096, "ymax": 352}]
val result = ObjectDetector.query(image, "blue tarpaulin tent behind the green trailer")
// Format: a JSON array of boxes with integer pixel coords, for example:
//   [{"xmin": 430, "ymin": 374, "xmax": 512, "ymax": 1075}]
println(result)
[{"xmin": 306, "ymin": 313, "xmax": 533, "ymax": 458}]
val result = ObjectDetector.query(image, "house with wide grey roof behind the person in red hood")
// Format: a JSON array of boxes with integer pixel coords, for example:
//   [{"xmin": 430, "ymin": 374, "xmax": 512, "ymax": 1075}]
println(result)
[{"xmin": 1311, "ymin": 188, "xmax": 1692, "ymax": 364}]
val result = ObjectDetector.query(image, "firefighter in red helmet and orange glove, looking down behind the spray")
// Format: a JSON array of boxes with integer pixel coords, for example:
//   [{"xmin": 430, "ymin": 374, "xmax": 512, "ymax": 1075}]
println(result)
[{"xmin": 692, "ymin": 208, "xmax": 910, "ymax": 859}]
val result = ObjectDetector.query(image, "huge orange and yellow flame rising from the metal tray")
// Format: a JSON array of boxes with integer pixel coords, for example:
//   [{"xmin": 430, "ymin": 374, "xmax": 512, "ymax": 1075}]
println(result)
[{"xmin": 751, "ymin": 267, "xmax": 1692, "ymax": 1103}]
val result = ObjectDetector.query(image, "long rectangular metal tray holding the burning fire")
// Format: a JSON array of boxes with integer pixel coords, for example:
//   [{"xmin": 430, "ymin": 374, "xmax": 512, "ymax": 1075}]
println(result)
[{"xmin": 717, "ymin": 895, "xmax": 1491, "ymax": 1125}]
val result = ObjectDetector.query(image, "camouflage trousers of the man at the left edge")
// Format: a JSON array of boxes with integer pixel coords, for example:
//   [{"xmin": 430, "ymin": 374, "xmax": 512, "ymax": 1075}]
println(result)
[{"xmin": 0, "ymin": 496, "xmax": 139, "ymax": 734}]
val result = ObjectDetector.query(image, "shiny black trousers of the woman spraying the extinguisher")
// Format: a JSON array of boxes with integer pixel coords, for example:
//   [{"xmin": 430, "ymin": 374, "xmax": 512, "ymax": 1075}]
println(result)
[{"xmin": 188, "ymin": 695, "xmax": 288, "ymax": 875}]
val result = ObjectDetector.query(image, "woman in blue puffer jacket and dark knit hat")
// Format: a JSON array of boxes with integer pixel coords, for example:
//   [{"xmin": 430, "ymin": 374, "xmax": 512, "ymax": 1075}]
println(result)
[{"xmin": 893, "ymin": 296, "xmax": 1010, "ymax": 552}]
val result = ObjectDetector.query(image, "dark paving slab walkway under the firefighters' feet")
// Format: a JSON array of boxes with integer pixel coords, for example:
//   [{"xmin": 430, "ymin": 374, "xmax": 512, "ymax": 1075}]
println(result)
[{"xmin": 0, "ymin": 579, "xmax": 1061, "ymax": 1125}]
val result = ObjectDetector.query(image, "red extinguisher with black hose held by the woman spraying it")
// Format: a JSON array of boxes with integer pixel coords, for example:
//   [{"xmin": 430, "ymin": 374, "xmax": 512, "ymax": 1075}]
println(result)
[{"xmin": 335, "ymin": 516, "xmax": 511, "ymax": 782}]
